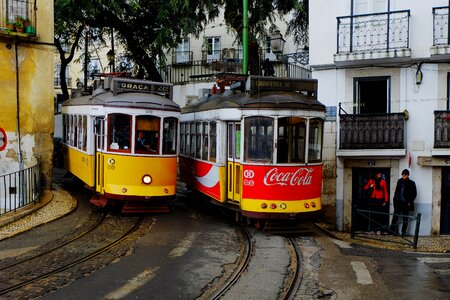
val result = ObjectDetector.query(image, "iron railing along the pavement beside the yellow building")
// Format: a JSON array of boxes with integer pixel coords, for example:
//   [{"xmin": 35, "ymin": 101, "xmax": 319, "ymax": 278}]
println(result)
[{"xmin": 0, "ymin": 163, "xmax": 42, "ymax": 215}]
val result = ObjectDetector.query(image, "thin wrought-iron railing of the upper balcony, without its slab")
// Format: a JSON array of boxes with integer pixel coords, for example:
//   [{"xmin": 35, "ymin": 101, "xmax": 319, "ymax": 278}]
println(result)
[{"xmin": 337, "ymin": 10, "xmax": 410, "ymax": 53}]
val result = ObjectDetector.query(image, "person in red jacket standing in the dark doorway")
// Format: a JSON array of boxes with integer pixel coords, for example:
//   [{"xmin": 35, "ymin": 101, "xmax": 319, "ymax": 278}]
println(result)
[{"xmin": 364, "ymin": 172, "xmax": 389, "ymax": 234}]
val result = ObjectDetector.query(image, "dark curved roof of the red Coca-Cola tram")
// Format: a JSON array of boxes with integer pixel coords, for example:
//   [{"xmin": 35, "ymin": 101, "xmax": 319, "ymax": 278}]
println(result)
[{"xmin": 181, "ymin": 90, "xmax": 326, "ymax": 113}]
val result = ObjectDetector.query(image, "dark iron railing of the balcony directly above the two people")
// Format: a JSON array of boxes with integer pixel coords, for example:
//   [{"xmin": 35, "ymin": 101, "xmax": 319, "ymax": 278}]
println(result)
[{"xmin": 339, "ymin": 113, "xmax": 405, "ymax": 149}]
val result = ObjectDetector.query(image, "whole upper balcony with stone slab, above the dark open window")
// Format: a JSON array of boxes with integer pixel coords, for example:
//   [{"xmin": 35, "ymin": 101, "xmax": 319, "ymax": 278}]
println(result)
[{"xmin": 334, "ymin": 10, "xmax": 411, "ymax": 66}]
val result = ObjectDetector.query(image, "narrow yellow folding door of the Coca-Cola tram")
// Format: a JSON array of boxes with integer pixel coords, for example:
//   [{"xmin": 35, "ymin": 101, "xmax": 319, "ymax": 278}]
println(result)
[{"xmin": 227, "ymin": 122, "xmax": 242, "ymax": 203}]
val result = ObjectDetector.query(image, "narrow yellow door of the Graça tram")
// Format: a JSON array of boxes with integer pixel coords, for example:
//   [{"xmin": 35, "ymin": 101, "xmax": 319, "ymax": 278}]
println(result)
[{"xmin": 94, "ymin": 117, "xmax": 105, "ymax": 193}]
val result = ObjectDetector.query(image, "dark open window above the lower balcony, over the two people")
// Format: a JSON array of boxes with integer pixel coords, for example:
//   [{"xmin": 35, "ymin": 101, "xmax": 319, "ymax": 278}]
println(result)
[{"xmin": 353, "ymin": 77, "xmax": 390, "ymax": 114}]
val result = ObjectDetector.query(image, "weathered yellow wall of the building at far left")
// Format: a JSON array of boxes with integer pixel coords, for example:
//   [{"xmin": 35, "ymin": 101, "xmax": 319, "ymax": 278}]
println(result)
[{"xmin": 0, "ymin": 0, "xmax": 54, "ymax": 188}]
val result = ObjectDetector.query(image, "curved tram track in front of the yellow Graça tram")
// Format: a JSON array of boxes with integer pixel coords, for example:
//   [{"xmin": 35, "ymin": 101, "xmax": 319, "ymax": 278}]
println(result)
[{"xmin": 0, "ymin": 216, "xmax": 144, "ymax": 298}]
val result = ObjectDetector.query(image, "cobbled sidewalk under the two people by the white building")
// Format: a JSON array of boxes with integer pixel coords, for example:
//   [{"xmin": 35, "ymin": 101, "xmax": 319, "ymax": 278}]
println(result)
[{"xmin": 316, "ymin": 222, "xmax": 450, "ymax": 253}]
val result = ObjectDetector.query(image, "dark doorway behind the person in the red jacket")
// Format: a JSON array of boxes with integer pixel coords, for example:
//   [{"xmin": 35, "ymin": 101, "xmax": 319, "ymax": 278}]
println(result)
[{"xmin": 352, "ymin": 168, "xmax": 392, "ymax": 231}]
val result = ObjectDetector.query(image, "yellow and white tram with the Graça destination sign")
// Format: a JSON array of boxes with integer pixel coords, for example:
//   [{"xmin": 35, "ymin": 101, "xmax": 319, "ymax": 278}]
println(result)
[{"xmin": 62, "ymin": 77, "xmax": 180, "ymax": 212}]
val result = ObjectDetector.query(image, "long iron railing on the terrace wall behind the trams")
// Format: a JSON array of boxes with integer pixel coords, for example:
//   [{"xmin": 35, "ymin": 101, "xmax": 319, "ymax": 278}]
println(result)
[{"xmin": 160, "ymin": 61, "xmax": 311, "ymax": 84}]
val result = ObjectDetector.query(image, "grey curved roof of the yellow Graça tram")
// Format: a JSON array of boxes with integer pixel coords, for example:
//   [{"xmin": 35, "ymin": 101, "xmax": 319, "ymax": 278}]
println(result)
[{"xmin": 63, "ymin": 91, "xmax": 180, "ymax": 111}]
